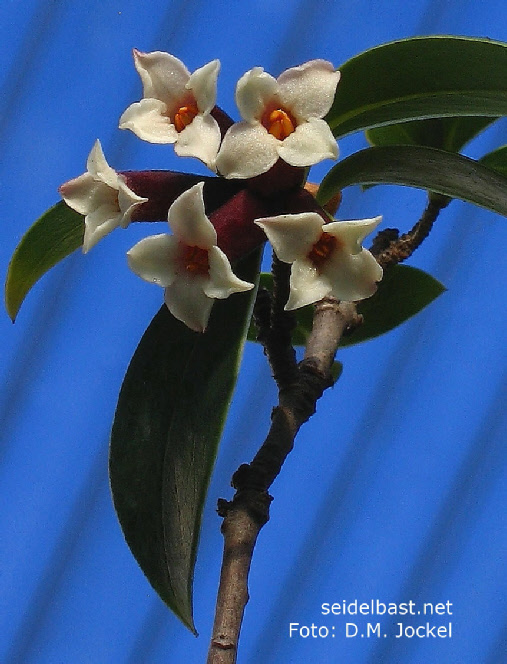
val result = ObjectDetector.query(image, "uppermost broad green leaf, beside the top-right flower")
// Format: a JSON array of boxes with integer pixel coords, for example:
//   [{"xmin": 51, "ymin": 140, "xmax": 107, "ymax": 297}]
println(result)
[{"xmin": 326, "ymin": 36, "xmax": 507, "ymax": 137}]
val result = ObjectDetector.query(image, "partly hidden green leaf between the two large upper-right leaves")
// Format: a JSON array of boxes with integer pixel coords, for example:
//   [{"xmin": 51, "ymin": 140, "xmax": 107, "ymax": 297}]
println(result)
[{"xmin": 366, "ymin": 117, "xmax": 498, "ymax": 152}]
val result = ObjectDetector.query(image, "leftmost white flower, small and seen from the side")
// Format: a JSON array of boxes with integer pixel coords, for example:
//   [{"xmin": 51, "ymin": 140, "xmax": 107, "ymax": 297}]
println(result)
[{"xmin": 59, "ymin": 140, "xmax": 148, "ymax": 254}]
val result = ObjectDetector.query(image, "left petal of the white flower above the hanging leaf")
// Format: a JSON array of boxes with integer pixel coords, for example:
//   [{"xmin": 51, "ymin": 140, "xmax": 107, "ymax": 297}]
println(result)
[{"xmin": 127, "ymin": 233, "xmax": 179, "ymax": 287}]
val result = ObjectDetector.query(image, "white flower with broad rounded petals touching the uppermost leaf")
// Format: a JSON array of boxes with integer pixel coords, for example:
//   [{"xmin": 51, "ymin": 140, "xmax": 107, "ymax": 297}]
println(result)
[{"xmin": 217, "ymin": 60, "xmax": 340, "ymax": 178}]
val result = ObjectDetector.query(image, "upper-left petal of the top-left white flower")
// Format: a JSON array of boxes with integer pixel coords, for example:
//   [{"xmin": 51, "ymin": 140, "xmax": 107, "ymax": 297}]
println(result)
[{"xmin": 134, "ymin": 49, "xmax": 190, "ymax": 108}]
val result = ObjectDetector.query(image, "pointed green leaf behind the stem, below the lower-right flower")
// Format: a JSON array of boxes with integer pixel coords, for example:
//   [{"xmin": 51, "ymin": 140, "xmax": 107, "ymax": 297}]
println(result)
[{"xmin": 248, "ymin": 265, "xmax": 445, "ymax": 347}]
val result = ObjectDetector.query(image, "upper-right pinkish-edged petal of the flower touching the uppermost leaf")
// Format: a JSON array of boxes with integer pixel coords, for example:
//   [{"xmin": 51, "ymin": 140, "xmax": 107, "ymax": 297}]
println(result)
[{"xmin": 278, "ymin": 60, "xmax": 340, "ymax": 122}]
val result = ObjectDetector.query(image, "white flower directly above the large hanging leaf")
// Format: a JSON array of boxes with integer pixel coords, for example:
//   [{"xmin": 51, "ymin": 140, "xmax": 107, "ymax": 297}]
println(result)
[{"xmin": 127, "ymin": 182, "xmax": 253, "ymax": 332}]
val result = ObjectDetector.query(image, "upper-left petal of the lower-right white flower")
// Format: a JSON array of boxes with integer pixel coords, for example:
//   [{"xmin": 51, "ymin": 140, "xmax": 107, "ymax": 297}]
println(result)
[{"xmin": 255, "ymin": 212, "xmax": 323, "ymax": 263}]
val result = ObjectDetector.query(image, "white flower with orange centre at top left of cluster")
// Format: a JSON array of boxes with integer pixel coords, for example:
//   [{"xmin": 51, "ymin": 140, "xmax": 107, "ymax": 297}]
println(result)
[{"xmin": 120, "ymin": 49, "xmax": 220, "ymax": 170}]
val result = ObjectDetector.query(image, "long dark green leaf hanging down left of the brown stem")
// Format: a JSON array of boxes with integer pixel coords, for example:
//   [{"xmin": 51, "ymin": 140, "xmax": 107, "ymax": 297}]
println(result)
[{"xmin": 109, "ymin": 251, "xmax": 260, "ymax": 633}]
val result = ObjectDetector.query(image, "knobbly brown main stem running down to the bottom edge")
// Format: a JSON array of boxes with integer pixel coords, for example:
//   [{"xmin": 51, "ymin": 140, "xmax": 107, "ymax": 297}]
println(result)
[{"xmin": 207, "ymin": 298, "xmax": 357, "ymax": 664}]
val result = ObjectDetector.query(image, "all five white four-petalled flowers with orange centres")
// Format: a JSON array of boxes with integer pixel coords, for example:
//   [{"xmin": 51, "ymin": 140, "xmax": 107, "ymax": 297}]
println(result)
[{"xmin": 60, "ymin": 50, "xmax": 382, "ymax": 332}]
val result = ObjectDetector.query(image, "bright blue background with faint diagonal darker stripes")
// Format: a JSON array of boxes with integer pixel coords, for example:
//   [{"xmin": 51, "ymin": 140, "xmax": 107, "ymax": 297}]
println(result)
[{"xmin": 0, "ymin": 0, "xmax": 507, "ymax": 664}]
